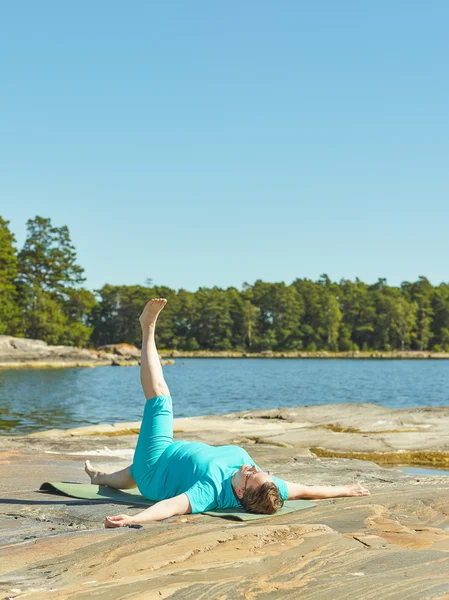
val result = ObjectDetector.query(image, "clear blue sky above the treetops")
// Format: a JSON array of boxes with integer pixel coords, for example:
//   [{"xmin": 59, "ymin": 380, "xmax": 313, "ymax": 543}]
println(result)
[{"xmin": 0, "ymin": 0, "xmax": 449, "ymax": 290}]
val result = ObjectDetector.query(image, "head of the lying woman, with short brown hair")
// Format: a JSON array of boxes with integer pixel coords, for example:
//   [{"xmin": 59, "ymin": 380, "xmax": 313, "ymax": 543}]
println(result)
[{"xmin": 233, "ymin": 465, "xmax": 284, "ymax": 515}]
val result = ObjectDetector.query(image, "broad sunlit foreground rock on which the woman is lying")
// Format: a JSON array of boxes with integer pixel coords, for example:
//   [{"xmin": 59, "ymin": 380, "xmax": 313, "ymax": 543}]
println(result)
[{"xmin": 0, "ymin": 404, "xmax": 449, "ymax": 600}]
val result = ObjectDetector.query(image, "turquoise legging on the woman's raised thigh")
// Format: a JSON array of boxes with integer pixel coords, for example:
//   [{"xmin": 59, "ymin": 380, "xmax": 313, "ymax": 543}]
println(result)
[{"xmin": 130, "ymin": 396, "xmax": 174, "ymax": 489}]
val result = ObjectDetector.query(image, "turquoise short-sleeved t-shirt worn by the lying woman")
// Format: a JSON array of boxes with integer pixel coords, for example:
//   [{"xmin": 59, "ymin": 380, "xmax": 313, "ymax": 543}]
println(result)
[{"xmin": 139, "ymin": 440, "xmax": 288, "ymax": 513}]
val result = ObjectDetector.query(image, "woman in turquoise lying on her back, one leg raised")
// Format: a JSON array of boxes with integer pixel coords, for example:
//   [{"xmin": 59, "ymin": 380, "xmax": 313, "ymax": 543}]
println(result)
[{"xmin": 86, "ymin": 298, "xmax": 369, "ymax": 527}]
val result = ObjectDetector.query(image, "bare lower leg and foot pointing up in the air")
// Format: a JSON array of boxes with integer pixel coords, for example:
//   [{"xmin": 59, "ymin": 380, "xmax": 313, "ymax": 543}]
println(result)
[{"xmin": 139, "ymin": 298, "xmax": 170, "ymax": 400}]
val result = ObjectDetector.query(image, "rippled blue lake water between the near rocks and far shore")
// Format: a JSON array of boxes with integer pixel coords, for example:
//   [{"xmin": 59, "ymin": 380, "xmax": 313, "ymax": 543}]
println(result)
[{"xmin": 0, "ymin": 359, "xmax": 449, "ymax": 434}]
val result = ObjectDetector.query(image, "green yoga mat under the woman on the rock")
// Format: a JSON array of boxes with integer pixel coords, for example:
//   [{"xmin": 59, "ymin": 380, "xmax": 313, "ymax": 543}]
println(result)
[{"xmin": 39, "ymin": 481, "xmax": 315, "ymax": 521}]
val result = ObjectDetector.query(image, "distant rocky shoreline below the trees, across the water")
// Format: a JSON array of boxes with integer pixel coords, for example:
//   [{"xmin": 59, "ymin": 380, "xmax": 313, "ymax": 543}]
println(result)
[{"xmin": 0, "ymin": 335, "xmax": 449, "ymax": 369}]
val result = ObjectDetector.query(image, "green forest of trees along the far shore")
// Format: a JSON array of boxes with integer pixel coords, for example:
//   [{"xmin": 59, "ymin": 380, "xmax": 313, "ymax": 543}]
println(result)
[{"xmin": 0, "ymin": 216, "xmax": 449, "ymax": 352}]
